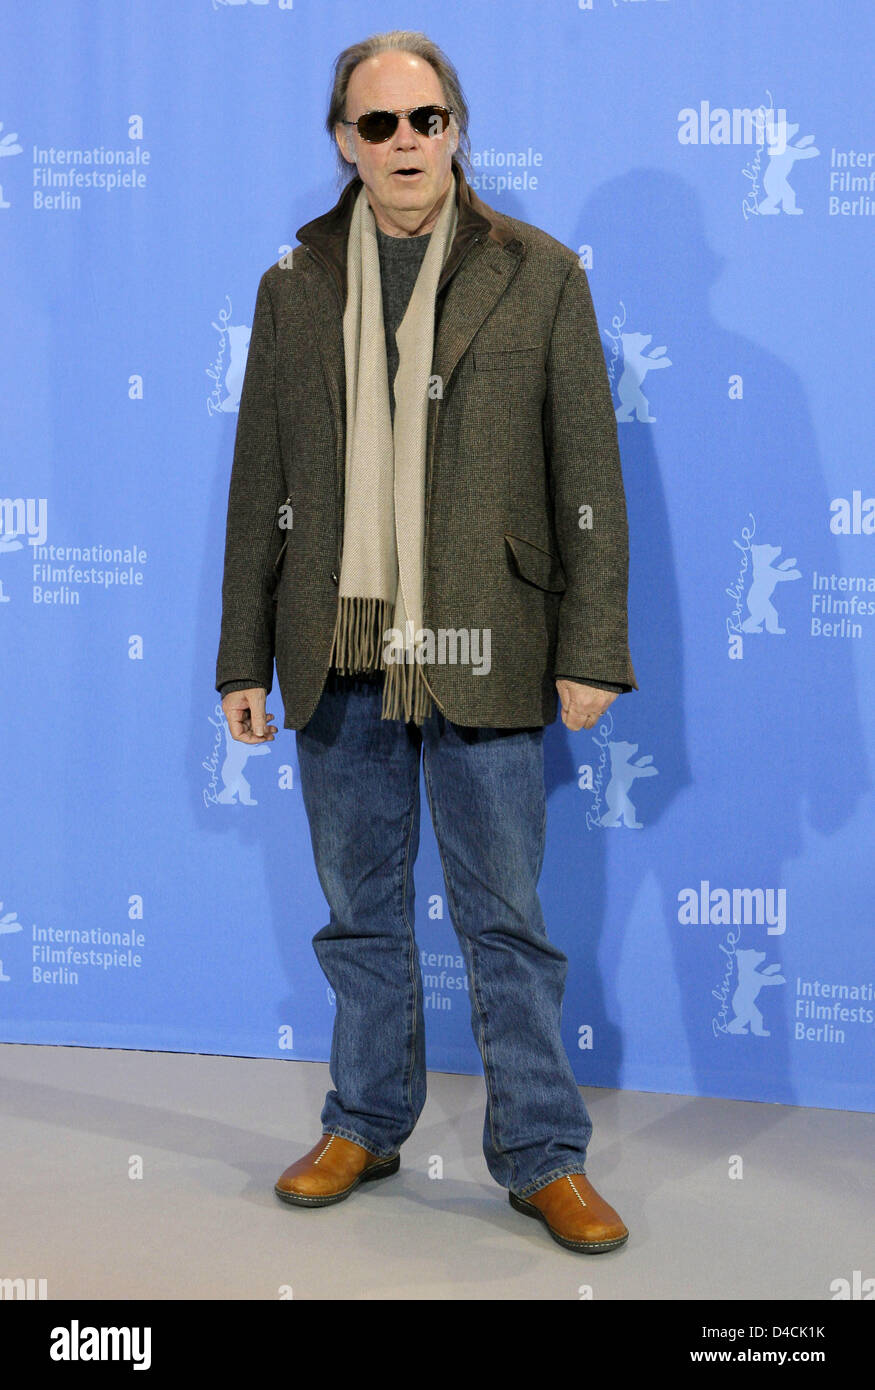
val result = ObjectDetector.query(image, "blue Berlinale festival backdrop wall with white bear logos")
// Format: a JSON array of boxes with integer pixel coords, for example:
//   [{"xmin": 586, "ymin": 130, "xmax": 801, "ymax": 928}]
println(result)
[{"xmin": 0, "ymin": 0, "xmax": 875, "ymax": 1109}]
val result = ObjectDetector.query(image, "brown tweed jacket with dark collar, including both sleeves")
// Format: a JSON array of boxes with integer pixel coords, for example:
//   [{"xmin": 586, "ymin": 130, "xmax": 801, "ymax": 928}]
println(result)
[{"xmin": 216, "ymin": 160, "xmax": 637, "ymax": 728}]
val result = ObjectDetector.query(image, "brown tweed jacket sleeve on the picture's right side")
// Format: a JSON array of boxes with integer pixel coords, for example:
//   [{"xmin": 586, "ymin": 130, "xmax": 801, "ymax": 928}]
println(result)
[{"xmin": 544, "ymin": 263, "xmax": 639, "ymax": 691}]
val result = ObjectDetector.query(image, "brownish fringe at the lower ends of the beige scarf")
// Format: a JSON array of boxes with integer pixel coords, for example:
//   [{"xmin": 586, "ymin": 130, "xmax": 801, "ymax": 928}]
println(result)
[{"xmin": 331, "ymin": 595, "xmax": 434, "ymax": 724}]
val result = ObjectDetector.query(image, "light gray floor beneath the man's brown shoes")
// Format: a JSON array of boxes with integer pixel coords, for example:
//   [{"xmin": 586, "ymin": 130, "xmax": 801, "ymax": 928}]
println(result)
[{"xmin": 0, "ymin": 1044, "xmax": 875, "ymax": 1300}]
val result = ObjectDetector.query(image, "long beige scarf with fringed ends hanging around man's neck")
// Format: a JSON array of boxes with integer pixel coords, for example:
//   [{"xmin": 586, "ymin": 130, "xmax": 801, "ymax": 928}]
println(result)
[{"xmin": 331, "ymin": 178, "xmax": 456, "ymax": 724}]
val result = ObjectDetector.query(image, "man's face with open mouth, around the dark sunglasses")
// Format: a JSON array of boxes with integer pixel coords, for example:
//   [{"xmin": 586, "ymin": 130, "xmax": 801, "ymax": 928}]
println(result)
[{"xmin": 335, "ymin": 53, "xmax": 459, "ymax": 236}]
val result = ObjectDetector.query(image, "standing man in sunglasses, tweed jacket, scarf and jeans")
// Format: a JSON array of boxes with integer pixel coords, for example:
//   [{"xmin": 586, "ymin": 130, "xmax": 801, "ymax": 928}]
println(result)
[{"xmin": 216, "ymin": 32, "xmax": 637, "ymax": 1252}]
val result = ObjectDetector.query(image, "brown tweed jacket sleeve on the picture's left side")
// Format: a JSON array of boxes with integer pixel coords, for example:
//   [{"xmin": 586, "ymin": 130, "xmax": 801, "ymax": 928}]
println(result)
[{"xmin": 216, "ymin": 271, "xmax": 287, "ymax": 694}]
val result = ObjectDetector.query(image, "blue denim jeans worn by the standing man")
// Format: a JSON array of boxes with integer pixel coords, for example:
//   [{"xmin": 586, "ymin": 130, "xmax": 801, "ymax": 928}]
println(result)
[{"xmin": 296, "ymin": 673, "xmax": 593, "ymax": 1197}]
